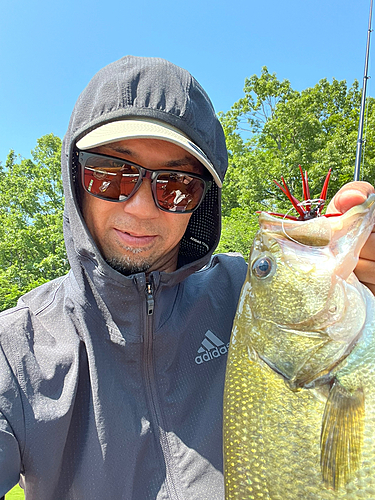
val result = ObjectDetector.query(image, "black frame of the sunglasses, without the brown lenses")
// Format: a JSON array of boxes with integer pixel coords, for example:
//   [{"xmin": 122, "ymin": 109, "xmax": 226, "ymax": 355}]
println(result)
[{"xmin": 78, "ymin": 151, "xmax": 213, "ymax": 214}]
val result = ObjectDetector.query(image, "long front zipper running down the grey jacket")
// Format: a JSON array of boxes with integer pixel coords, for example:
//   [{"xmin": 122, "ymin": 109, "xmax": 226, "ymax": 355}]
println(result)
[{"xmin": 144, "ymin": 277, "xmax": 180, "ymax": 500}]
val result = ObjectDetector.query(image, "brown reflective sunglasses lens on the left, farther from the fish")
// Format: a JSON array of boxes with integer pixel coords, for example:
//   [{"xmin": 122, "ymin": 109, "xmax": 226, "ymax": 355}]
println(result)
[{"xmin": 84, "ymin": 156, "xmax": 139, "ymax": 201}]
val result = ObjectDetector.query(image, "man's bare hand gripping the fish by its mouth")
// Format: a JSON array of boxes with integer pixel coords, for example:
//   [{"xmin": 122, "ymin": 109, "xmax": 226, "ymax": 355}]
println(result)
[{"xmin": 327, "ymin": 182, "xmax": 375, "ymax": 295}]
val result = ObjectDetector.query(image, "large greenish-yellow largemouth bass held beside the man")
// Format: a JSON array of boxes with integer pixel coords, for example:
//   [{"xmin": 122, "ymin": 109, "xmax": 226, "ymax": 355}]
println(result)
[{"xmin": 224, "ymin": 195, "xmax": 375, "ymax": 500}]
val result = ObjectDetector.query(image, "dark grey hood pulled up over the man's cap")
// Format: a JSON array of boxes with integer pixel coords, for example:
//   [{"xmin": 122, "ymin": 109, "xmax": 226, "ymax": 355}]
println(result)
[{"xmin": 62, "ymin": 56, "xmax": 227, "ymax": 292}]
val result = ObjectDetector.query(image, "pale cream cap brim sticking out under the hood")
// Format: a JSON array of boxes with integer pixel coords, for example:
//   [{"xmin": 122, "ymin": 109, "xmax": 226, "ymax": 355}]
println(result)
[{"xmin": 77, "ymin": 118, "xmax": 222, "ymax": 188}]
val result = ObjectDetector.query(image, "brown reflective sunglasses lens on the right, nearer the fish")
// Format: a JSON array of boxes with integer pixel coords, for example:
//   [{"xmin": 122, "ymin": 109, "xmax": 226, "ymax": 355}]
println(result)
[{"xmin": 156, "ymin": 172, "xmax": 205, "ymax": 212}]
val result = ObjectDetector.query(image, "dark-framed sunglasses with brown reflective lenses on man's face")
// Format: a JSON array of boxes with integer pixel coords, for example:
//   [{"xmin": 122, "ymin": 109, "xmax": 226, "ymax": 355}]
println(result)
[{"xmin": 78, "ymin": 151, "xmax": 212, "ymax": 214}]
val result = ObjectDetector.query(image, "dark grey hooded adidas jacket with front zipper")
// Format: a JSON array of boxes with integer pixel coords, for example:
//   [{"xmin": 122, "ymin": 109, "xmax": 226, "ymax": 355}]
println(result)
[{"xmin": 0, "ymin": 57, "xmax": 246, "ymax": 500}]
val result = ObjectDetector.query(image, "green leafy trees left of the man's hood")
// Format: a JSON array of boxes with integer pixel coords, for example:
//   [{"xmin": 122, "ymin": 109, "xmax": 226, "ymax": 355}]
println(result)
[{"xmin": 0, "ymin": 134, "xmax": 68, "ymax": 310}]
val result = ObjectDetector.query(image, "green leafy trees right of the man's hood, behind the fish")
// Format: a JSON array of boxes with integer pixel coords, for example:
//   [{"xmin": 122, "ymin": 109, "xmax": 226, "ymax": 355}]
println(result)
[{"xmin": 218, "ymin": 67, "xmax": 375, "ymax": 255}]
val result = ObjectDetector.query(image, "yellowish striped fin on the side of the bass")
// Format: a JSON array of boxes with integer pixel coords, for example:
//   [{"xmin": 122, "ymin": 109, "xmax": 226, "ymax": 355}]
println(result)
[{"xmin": 320, "ymin": 380, "xmax": 365, "ymax": 490}]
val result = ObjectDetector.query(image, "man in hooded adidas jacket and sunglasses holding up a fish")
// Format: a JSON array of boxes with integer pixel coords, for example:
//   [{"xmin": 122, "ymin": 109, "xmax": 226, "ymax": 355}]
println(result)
[{"xmin": 0, "ymin": 57, "xmax": 375, "ymax": 500}]
